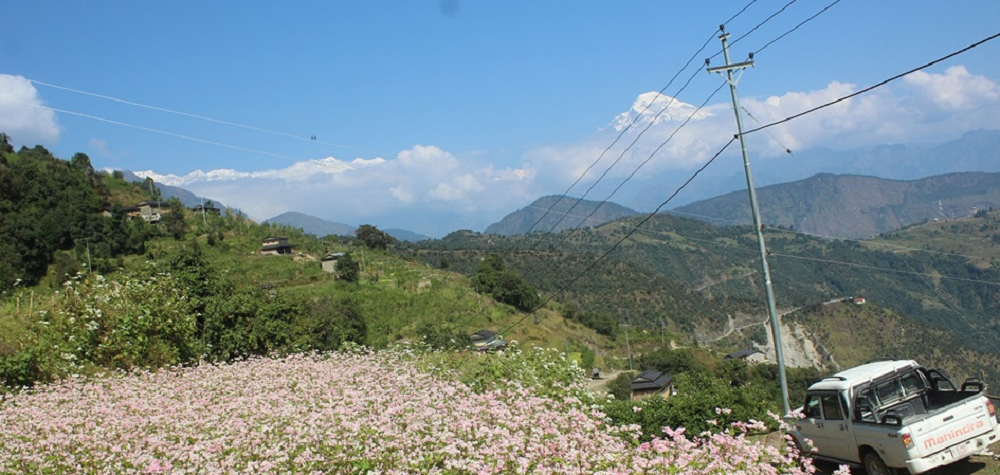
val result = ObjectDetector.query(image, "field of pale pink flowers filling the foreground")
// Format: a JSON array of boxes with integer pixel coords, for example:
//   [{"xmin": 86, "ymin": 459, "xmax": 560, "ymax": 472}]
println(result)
[{"xmin": 0, "ymin": 351, "xmax": 828, "ymax": 474}]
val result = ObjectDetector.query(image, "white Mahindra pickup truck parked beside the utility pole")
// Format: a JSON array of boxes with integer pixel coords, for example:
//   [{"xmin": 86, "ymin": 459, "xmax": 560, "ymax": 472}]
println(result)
[{"xmin": 790, "ymin": 361, "xmax": 1000, "ymax": 475}]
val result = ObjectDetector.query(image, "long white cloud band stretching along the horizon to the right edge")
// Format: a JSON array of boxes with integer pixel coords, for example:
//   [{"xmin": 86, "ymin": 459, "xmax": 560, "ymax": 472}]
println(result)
[{"xmin": 129, "ymin": 67, "xmax": 1000, "ymax": 236}]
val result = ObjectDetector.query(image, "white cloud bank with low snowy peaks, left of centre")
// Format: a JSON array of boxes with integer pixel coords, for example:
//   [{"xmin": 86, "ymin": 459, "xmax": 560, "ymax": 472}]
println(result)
[{"xmin": 157, "ymin": 145, "xmax": 538, "ymax": 235}]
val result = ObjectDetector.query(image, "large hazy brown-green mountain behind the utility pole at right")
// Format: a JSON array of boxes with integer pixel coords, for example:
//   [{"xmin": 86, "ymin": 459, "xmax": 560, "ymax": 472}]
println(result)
[{"xmin": 674, "ymin": 172, "xmax": 1000, "ymax": 239}]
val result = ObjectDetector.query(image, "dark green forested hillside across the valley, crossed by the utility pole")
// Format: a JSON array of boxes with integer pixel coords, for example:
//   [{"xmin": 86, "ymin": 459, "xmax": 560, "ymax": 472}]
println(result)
[{"xmin": 402, "ymin": 211, "xmax": 1000, "ymax": 360}]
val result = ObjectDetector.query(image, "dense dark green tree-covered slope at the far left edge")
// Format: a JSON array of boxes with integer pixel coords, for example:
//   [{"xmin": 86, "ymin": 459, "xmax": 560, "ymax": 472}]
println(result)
[{"xmin": 0, "ymin": 135, "xmax": 155, "ymax": 292}]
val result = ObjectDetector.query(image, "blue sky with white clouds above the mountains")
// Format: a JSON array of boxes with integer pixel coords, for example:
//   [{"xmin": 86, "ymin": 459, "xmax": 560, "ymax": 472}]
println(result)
[{"xmin": 0, "ymin": 0, "xmax": 1000, "ymax": 237}]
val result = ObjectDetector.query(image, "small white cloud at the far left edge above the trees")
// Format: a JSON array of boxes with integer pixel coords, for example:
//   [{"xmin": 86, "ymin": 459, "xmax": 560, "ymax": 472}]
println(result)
[{"xmin": 0, "ymin": 74, "xmax": 60, "ymax": 145}]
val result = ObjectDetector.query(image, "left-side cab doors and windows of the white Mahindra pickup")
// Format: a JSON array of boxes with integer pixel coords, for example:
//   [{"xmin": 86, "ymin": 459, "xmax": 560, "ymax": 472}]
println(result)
[{"xmin": 796, "ymin": 391, "xmax": 858, "ymax": 462}]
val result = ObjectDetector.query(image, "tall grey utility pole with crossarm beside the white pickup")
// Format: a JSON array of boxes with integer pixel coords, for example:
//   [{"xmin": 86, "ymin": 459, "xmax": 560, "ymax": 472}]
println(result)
[{"xmin": 705, "ymin": 25, "xmax": 791, "ymax": 414}]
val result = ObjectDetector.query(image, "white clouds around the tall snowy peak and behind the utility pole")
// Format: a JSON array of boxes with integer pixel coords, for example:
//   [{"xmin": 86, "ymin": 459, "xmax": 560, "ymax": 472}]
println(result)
[{"xmin": 524, "ymin": 70, "xmax": 1000, "ymax": 203}]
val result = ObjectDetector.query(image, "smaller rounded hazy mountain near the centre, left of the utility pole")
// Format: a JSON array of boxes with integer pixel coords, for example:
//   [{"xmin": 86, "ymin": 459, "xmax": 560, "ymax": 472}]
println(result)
[{"xmin": 485, "ymin": 195, "xmax": 639, "ymax": 236}]
